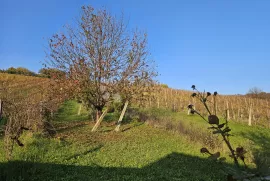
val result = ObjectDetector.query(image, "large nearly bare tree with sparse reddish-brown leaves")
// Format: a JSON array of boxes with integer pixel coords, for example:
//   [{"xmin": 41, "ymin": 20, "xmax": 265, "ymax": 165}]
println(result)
[{"xmin": 46, "ymin": 6, "xmax": 156, "ymax": 127}]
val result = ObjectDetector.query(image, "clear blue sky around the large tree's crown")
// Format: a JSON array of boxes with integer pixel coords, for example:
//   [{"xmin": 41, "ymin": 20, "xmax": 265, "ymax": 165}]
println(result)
[{"xmin": 0, "ymin": 0, "xmax": 270, "ymax": 94}]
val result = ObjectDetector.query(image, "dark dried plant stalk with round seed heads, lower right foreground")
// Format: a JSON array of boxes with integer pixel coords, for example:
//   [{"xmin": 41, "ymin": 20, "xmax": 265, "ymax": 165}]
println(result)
[{"xmin": 188, "ymin": 85, "xmax": 269, "ymax": 181}]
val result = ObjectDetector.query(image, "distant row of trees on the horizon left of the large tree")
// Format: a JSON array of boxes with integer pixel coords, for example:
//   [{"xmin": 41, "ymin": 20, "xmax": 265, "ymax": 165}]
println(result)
[{"xmin": 0, "ymin": 67, "xmax": 64, "ymax": 78}]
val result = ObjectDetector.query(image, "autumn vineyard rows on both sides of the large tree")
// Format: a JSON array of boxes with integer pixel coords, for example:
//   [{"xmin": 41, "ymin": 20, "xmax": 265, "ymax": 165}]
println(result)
[{"xmin": 0, "ymin": 73, "xmax": 270, "ymax": 144}]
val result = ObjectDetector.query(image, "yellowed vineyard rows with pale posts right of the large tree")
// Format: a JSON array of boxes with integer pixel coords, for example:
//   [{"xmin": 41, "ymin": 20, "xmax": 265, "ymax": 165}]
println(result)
[{"xmin": 146, "ymin": 87, "xmax": 270, "ymax": 128}]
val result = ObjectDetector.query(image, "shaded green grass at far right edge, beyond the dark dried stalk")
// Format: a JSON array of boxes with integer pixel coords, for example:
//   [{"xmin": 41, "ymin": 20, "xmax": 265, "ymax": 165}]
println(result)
[{"xmin": 241, "ymin": 132, "xmax": 270, "ymax": 174}]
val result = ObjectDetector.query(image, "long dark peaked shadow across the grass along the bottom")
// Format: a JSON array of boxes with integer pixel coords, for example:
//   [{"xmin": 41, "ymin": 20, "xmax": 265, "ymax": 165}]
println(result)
[{"xmin": 0, "ymin": 153, "xmax": 232, "ymax": 181}]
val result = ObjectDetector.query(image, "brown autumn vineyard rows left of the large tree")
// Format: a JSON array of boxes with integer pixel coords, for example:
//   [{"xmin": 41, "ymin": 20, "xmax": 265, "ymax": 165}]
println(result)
[{"xmin": 0, "ymin": 73, "xmax": 73, "ymax": 158}]
